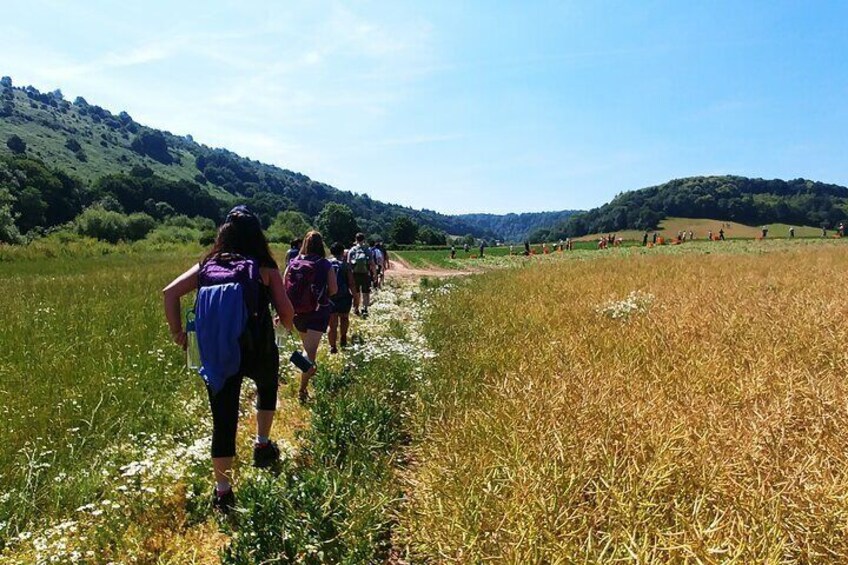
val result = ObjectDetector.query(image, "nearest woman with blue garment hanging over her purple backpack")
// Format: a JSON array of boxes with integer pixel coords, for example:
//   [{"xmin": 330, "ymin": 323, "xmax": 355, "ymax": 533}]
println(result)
[{"xmin": 162, "ymin": 206, "xmax": 294, "ymax": 514}]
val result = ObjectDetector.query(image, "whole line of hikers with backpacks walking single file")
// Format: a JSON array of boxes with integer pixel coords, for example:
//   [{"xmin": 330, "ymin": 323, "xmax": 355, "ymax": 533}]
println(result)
[{"xmin": 163, "ymin": 206, "xmax": 390, "ymax": 514}]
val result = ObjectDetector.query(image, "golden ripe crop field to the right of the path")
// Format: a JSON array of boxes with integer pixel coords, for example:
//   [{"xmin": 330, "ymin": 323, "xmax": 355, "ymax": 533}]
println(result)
[{"xmin": 398, "ymin": 242, "xmax": 848, "ymax": 563}]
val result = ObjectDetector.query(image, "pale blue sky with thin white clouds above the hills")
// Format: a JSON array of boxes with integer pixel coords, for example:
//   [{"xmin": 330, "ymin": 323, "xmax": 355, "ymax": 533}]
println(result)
[{"xmin": 0, "ymin": 0, "xmax": 848, "ymax": 213}]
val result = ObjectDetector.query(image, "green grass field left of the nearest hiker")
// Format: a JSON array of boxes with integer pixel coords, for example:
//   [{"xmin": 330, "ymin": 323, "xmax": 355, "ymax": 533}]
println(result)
[{"xmin": 0, "ymin": 250, "xmax": 203, "ymax": 546}]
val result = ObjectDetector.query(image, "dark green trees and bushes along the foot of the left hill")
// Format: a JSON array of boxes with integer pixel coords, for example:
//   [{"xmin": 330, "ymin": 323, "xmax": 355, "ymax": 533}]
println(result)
[{"xmin": 0, "ymin": 155, "xmax": 447, "ymax": 245}]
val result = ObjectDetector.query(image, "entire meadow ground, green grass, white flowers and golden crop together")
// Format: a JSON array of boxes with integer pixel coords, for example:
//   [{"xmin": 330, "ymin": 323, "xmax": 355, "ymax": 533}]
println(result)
[{"xmin": 0, "ymin": 238, "xmax": 848, "ymax": 563}]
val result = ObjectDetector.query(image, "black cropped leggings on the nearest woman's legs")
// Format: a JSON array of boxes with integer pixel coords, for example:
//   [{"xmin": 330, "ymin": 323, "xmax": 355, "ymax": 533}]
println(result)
[{"xmin": 206, "ymin": 373, "xmax": 279, "ymax": 457}]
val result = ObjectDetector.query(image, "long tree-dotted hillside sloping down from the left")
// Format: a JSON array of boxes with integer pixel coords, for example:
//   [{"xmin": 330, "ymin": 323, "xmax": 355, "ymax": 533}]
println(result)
[{"xmin": 0, "ymin": 77, "xmax": 495, "ymax": 243}]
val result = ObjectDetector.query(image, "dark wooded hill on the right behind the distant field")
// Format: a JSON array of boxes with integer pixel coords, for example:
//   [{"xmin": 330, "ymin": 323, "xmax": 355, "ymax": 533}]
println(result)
[{"xmin": 537, "ymin": 176, "xmax": 848, "ymax": 240}]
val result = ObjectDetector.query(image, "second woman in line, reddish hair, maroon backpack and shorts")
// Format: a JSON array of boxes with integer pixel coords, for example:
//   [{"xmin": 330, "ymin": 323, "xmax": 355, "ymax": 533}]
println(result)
[{"xmin": 283, "ymin": 230, "xmax": 338, "ymax": 403}]
